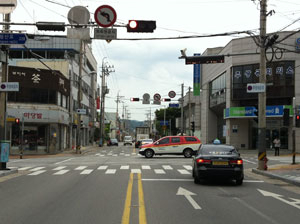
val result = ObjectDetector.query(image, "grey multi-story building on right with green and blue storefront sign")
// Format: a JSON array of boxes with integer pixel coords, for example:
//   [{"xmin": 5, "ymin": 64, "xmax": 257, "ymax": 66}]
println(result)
[{"xmin": 200, "ymin": 32, "xmax": 300, "ymax": 151}]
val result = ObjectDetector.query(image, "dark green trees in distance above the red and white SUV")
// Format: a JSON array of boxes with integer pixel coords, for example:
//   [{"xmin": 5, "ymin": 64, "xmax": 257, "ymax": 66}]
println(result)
[{"xmin": 155, "ymin": 107, "xmax": 181, "ymax": 136}]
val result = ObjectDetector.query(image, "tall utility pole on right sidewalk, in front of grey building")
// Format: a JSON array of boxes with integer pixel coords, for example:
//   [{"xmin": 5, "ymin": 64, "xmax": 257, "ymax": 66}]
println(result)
[{"xmin": 258, "ymin": 0, "xmax": 267, "ymax": 170}]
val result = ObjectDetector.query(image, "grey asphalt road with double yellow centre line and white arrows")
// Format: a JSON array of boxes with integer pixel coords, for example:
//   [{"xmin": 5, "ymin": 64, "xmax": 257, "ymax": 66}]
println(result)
[{"xmin": 0, "ymin": 146, "xmax": 300, "ymax": 224}]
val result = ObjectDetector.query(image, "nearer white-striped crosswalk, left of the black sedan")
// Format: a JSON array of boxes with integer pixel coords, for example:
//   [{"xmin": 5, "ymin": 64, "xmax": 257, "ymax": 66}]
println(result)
[{"xmin": 18, "ymin": 165, "xmax": 193, "ymax": 176}]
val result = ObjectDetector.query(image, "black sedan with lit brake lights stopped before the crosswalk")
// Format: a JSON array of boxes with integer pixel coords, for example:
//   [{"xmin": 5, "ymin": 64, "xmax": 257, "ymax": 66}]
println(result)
[{"xmin": 193, "ymin": 144, "xmax": 244, "ymax": 185}]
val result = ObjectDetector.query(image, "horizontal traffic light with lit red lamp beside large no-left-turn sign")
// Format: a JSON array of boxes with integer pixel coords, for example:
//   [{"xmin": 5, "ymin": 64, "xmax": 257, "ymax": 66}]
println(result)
[{"xmin": 127, "ymin": 20, "xmax": 156, "ymax": 33}]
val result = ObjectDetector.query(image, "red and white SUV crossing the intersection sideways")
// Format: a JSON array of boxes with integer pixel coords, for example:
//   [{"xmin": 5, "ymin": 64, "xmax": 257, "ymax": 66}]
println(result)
[{"xmin": 139, "ymin": 136, "xmax": 201, "ymax": 158}]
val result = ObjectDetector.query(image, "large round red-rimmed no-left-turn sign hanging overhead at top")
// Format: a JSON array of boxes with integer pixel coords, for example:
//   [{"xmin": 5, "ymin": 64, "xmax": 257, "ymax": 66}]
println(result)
[{"xmin": 95, "ymin": 5, "xmax": 117, "ymax": 27}]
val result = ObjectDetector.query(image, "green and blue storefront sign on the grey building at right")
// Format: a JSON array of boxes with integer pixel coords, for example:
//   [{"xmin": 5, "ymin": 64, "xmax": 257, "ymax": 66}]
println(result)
[{"xmin": 224, "ymin": 105, "xmax": 294, "ymax": 119}]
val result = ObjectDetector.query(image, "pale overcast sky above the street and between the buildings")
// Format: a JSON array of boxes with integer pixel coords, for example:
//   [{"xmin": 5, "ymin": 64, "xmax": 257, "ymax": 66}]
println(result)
[{"xmin": 5, "ymin": 0, "xmax": 300, "ymax": 120}]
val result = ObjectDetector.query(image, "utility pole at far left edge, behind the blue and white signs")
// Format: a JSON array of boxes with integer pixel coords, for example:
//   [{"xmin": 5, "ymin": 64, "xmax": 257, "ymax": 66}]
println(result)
[{"xmin": 0, "ymin": 13, "xmax": 10, "ymax": 170}]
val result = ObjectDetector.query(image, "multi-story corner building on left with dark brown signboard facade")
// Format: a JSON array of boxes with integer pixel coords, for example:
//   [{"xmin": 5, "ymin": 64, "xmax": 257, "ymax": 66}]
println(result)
[{"xmin": 7, "ymin": 35, "xmax": 97, "ymax": 153}]
